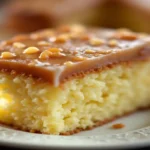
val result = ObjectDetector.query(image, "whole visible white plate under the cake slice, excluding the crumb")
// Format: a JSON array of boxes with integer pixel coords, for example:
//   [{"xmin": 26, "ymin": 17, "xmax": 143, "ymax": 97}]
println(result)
[{"xmin": 0, "ymin": 110, "xmax": 150, "ymax": 149}]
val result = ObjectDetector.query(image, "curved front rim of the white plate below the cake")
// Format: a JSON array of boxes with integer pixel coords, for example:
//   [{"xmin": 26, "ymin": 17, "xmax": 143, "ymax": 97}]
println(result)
[{"xmin": 0, "ymin": 126, "xmax": 150, "ymax": 149}]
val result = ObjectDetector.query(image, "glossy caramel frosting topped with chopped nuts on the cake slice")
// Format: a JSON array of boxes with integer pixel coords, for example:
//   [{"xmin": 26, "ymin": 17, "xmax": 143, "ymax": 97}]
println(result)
[{"xmin": 0, "ymin": 25, "xmax": 150, "ymax": 86}]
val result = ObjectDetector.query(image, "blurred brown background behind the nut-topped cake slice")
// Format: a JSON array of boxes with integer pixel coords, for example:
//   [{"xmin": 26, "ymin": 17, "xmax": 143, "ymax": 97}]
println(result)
[{"xmin": 0, "ymin": 0, "xmax": 150, "ymax": 39}]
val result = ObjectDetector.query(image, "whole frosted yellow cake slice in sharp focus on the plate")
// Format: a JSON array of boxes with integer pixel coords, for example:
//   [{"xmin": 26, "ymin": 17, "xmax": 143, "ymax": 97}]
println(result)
[{"xmin": 0, "ymin": 25, "xmax": 150, "ymax": 135}]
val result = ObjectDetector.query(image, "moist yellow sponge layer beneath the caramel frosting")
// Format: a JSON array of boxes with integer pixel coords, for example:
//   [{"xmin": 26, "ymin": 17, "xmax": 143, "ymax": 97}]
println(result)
[{"xmin": 0, "ymin": 60, "xmax": 150, "ymax": 134}]
